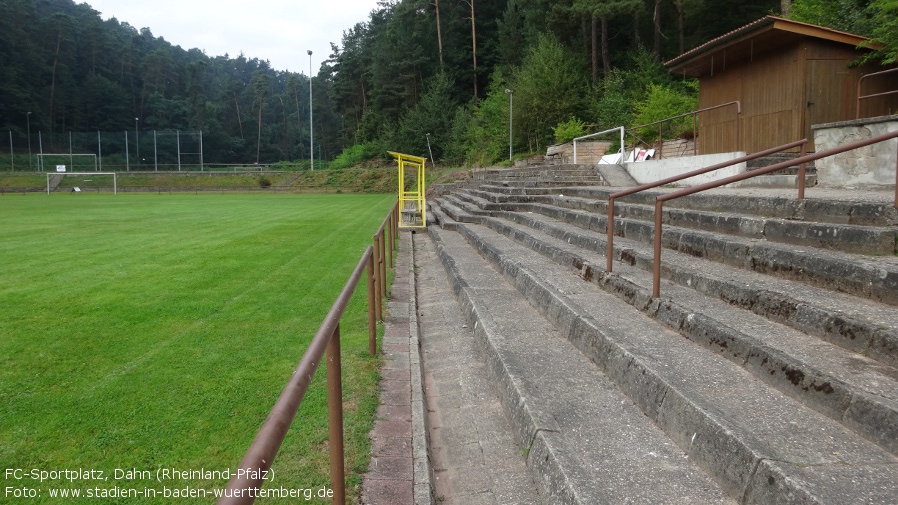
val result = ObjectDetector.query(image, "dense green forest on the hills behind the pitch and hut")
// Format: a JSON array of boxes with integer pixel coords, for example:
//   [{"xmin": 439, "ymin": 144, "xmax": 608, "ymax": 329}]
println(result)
[{"xmin": 0, "ymin": 0, "xmax": 898, "ymax": 166}]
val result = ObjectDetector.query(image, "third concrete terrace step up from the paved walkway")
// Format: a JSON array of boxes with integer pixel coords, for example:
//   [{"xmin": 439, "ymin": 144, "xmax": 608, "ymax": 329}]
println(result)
[{"xmin": 458, "ymin": 210, "xmax": 898, "ymax": 454}]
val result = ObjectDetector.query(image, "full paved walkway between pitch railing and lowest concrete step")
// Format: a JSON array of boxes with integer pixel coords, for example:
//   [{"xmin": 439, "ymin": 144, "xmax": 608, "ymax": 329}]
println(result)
[{"xmin": 362, "ymin": 232, "xmax": 539, "ymax": 505}]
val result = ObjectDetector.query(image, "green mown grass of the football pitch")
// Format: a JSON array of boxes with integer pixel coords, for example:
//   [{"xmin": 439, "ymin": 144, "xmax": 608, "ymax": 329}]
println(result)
[{"xmin": 0, "ymin": 194, "xmax": 394, "ymax": 503}]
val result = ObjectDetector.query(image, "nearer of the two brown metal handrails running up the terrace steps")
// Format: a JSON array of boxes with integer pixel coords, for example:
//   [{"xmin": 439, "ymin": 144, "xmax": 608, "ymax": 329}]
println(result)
[{"xmin": 652, "ymin": 131, "xmax": 898, "ymax": 298}]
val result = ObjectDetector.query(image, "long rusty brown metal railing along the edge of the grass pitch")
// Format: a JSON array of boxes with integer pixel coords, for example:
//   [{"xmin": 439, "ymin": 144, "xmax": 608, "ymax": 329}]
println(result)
[{"xmin": 217, "ymin": 203, "xmax": 398, "ymax": 505}]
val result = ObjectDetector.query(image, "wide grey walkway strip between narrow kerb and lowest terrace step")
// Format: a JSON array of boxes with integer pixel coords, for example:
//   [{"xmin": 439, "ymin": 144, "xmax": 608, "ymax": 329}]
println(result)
[{"xmin": 412, "ymin": 233, "xmax": 541, "ymax": 505}]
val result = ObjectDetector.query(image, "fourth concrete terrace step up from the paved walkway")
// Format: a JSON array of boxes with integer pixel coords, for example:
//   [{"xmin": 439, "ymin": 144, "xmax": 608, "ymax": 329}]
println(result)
[{"xmin": 469, "ymin": 206, "xmax": 898, "ymax": 366}]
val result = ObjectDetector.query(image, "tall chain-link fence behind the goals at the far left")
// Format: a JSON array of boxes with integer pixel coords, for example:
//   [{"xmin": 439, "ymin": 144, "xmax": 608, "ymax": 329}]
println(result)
[{"xmin": 0, "ymin": 130, "xmax": 208, "ymax": 172}]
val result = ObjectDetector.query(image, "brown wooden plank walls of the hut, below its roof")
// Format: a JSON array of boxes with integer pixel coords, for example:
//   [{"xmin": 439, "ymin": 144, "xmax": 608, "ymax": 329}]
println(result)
[{"xmin": 698, "ymin": 39, "xmax": 898, "ymax": 154}]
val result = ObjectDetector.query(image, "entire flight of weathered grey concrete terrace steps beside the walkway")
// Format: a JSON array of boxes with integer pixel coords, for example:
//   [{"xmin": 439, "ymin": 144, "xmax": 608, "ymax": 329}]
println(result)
[{"xmin": 428, "ymin": 174, "xmax": 898, "ymax": 504}]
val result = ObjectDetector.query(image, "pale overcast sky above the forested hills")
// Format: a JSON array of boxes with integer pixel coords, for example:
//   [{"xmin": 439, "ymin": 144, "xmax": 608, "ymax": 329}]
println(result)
[{"xmin": 82, "ymin": 0, "xmax": 377, "ymax": 75}]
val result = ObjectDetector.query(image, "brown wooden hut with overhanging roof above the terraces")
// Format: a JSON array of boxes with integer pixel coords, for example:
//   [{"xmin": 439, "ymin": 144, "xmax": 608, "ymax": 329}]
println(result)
[{"xmin": 666, "ymin": 16, "xmax": 898, "ymax": 154}]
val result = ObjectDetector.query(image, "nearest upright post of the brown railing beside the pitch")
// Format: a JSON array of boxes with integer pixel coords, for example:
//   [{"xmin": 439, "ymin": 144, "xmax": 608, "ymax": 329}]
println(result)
[{"xmin": 327, "ymin": 323, "xmax": 346, "ymax": 505}]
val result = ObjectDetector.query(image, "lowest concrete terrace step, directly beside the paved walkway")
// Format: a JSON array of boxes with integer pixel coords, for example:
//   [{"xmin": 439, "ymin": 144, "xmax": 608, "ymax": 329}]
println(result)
[{"xmin": 429, "ymin": 228, "xmax": 728, "ymax": 504}]
